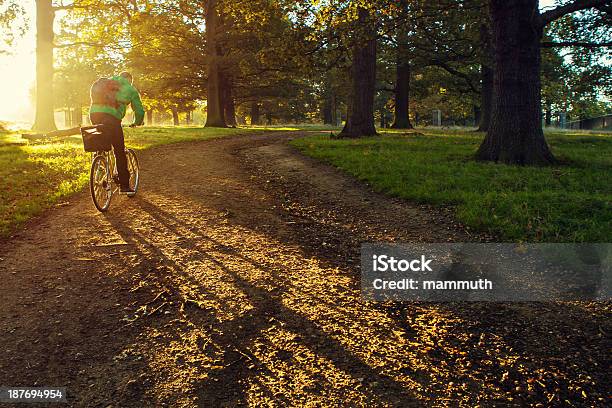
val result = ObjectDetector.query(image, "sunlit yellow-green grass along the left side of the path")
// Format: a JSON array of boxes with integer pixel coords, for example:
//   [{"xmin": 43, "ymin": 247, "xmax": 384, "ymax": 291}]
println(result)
[{"xmin": 0, "ymin": 127, "xmax": 249, "ymax": 236}]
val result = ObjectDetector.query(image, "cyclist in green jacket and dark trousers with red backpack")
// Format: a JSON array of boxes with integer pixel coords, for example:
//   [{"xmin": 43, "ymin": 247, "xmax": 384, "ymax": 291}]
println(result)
[{"xmin": 89, "ymin": 72, "xmax": 144, "ymax": 193}]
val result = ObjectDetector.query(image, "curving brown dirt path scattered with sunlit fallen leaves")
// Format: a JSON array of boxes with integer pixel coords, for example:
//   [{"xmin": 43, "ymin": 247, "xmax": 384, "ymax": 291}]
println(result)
[{"xmin": 0, "ymin": 133, "xmax": 610, "ymax": 407}]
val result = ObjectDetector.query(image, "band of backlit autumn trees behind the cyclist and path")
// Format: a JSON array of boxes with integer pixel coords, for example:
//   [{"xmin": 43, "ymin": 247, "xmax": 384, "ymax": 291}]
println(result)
[{"xmin": 0, "ymin": 0, "xmax": 612, "ymax": 161}]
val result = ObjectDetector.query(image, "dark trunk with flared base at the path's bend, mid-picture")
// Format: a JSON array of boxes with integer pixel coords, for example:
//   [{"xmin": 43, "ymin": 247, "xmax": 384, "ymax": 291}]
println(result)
[{"xmin": 338, "ymin": 7, "xmax": 376, "ymax": 137}]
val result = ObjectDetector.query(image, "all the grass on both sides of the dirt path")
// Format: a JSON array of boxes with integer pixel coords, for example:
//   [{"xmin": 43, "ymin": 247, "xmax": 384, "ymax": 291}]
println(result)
[{"xmin": 0, "ymin": 126, "xmax": 612, "ymax": 242}]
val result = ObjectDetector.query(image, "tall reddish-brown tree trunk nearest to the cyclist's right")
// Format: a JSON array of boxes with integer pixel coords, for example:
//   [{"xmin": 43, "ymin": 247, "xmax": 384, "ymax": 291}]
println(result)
[{"xmin": 205, "ymin": 0, "xmax": 227, "ymax": 127}]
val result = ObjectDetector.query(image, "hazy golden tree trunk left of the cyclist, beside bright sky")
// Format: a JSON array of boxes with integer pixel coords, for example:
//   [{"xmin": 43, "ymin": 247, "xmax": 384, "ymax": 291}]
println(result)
[{"xmin": 32, "ymin": 0, "xmax": 57, "ymax": 132}]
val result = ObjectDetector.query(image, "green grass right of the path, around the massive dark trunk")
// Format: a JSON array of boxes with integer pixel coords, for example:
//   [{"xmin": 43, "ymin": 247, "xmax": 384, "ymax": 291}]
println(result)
[{"xmin": 292, "ymin": 129, "xmax": 612, "ymax": 242}]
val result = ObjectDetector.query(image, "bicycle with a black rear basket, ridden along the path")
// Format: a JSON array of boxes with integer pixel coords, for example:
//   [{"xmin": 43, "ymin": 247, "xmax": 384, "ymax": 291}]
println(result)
[{"xmin": 81, "ymin": 125, "xmax": 140, "ymax": 212}]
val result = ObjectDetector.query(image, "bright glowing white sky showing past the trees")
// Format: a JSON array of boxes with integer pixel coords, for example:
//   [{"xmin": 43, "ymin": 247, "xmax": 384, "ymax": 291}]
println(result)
[{"xmin": 0, "ymin": 0, "xmax": 555, "ymax": 123}]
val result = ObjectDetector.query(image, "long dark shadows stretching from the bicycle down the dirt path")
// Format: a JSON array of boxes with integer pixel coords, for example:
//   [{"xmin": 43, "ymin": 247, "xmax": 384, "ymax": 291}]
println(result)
[{"xmin": 107, "ymin": 198, "xmax": 416, "ymax": 406}]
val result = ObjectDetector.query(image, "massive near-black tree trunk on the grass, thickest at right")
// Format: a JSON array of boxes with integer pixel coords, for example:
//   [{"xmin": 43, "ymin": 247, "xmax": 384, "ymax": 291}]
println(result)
[{"xmin": 477, "ymin": 0, "xmax": 554, "ymax": 165}]
